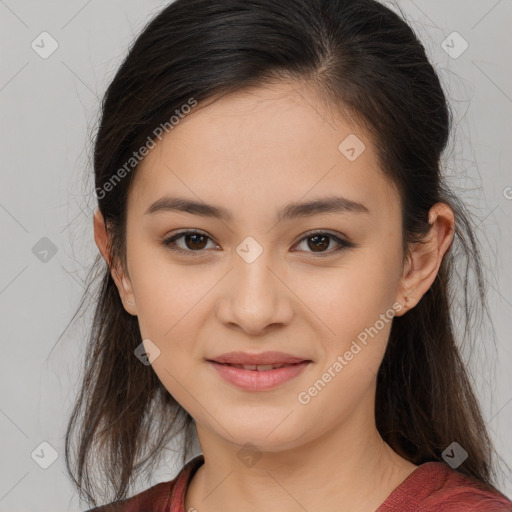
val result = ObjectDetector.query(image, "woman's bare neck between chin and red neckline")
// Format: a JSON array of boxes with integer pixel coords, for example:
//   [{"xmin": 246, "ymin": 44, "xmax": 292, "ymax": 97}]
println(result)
[{"xmin": 185, "ymin": 392, "xmax": 416, "ymax": 512}]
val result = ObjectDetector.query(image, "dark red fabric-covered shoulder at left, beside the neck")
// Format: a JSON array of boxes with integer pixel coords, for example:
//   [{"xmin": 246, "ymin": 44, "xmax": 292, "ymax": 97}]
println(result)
[{"xmin": 86, "ymin": 455, "xmax": 204, "ymax": 512}]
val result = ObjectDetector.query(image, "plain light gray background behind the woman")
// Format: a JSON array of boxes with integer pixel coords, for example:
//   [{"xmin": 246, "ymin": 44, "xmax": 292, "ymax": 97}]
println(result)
[{"xmin": 0, "ymin": 0, "xmax": 512, "ymax": 512}]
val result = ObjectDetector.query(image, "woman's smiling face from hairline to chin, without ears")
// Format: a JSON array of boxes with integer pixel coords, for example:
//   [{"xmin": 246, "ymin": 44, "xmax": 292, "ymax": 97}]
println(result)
[{"xmin": 108, "ymin": 82, "xmax": 412, "ymax": 452}]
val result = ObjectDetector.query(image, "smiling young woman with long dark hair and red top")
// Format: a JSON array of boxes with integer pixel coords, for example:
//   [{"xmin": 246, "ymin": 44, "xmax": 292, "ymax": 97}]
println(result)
[{"xmin": 66, "ymin": 0, "xmax": 512, "ymax": 512}]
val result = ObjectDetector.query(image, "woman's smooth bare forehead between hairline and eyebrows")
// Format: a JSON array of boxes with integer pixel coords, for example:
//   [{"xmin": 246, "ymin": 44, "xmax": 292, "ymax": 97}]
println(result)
[{"xmin": 129, "ymin": 82, "xmax": 397, "ymax": 224}]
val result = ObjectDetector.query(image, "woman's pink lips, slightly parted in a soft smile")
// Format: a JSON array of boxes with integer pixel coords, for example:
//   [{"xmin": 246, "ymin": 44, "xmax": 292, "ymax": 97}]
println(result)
[{"xmin": 208, "ymin": 352, "xmax": 312, "ymax": 391}]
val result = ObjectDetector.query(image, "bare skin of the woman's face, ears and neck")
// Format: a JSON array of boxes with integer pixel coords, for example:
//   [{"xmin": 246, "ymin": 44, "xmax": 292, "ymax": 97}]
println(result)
[{"xmin": 94, "ymin": 81, "xmax": 454, "ymax": 512}]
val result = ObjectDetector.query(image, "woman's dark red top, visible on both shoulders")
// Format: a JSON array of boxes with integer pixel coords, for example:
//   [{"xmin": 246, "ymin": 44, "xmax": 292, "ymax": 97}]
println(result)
[{"xmin": 87, "ymin": 455, "xmax": 512, "ymax": 512}]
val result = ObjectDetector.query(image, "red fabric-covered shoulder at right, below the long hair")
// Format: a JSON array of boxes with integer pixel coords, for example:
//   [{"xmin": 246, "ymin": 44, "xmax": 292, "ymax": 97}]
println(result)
[{"xmin": 378, "ymin": 462, "xmax": 512, "ymax": 512}]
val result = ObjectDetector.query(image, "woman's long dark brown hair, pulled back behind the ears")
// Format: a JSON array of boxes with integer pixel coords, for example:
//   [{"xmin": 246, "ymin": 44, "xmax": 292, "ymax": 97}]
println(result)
[{"xmin": 66, "ymin": 0, "xmax": 504, "ymax": 505}]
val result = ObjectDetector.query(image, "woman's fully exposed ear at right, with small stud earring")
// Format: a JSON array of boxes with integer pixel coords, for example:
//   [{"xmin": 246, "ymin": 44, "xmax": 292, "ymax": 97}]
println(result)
[{"xmin": 396, "ymin": 203, "xmax": 455, "ymax": 316}]
